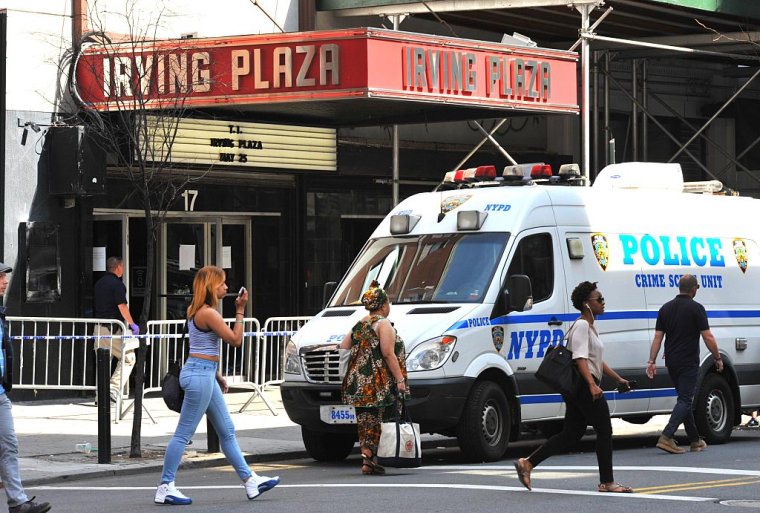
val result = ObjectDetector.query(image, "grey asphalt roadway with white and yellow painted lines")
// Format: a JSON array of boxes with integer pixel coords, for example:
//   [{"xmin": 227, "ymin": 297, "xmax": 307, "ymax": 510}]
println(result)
[{"xmin": 28, "ymin": 431, "xmax": 760, "ymax": 513}]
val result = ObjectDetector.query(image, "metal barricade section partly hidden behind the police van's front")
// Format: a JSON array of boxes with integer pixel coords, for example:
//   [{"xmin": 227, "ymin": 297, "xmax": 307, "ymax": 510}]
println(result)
[{"xmin": 240, "ymin": 316, "xmax": 311, "ymax": 415}]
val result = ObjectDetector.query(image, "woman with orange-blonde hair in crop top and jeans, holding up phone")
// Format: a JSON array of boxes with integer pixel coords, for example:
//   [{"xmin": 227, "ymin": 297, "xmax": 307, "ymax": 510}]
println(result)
[{"xmin": 153, "ymin": 265, "xmax": 280, "ymax": 504}]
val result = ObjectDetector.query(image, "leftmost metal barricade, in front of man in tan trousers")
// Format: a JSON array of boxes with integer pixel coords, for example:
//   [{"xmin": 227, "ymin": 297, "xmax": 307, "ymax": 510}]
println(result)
[{"xmin": 7, "ymin": 316, "xmax": 126, "ymax": 392}]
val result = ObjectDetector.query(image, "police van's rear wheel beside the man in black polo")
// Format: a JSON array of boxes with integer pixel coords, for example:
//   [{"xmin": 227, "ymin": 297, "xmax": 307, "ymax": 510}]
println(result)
[{"xmin": 694, "ymin": 374, "xmax": 734, "ymax": 444}]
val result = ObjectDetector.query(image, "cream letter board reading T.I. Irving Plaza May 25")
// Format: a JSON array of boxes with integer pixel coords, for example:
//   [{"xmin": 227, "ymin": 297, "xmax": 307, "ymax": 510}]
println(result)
[{"xmin": 147, "ymin": 117, "xmax": 337, "ymax": 171}]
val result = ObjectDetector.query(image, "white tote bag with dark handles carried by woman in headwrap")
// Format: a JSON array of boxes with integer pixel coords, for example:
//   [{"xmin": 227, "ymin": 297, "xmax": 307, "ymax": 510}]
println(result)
[{"xmin": 377, "ymin": 399, "xmax": 422, "ymax": 468}]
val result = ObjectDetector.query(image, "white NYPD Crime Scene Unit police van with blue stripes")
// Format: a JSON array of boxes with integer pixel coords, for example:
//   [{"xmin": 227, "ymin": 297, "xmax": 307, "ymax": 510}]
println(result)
[{"xmin": 282, "ymin": 163, "xmax": 760, "ymax": 461}]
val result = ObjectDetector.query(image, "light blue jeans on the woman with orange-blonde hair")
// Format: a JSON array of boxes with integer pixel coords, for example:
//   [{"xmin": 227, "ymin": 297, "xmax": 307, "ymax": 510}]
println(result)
[{"xmin": 161, "ymin": 358, "xmax": 252, "ymax": 483}]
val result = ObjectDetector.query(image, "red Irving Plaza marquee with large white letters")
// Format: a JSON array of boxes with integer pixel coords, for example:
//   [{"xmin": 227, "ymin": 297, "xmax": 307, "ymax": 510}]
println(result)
[{"xmin": 76, "ymin": 28, "xmax": 579, "ymax": 113}]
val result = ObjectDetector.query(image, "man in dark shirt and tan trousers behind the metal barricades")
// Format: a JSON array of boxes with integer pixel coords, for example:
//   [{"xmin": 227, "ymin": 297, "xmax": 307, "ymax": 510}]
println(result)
[{"xmin": 94, "ymin": 257, "xmax": 140, "ymax": 401}]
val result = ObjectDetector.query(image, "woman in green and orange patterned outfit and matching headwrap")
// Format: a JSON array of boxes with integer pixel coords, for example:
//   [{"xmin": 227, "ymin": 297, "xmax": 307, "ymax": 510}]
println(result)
[{"xmin": 340, "ymin": 281, "xmax": 409, "ymax": 474}]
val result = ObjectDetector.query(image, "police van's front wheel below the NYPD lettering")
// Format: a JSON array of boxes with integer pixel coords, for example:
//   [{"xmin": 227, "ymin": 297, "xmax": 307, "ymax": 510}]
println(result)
[{"xmin": 457, "ymin": 381, "xmax": 511, "ymax": 461}]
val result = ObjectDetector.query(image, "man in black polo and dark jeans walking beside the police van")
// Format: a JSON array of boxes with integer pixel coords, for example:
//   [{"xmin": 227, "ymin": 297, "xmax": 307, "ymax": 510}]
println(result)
[{"xmin": 647, "ymin": 274, "xmax": 723, "ymax": 454}]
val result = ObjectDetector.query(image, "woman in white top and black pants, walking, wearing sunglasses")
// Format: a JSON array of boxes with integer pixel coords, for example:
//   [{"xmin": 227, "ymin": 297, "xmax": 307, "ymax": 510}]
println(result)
[{"xmin": 515, "ymin": 281, "xmax": 633, "ymax": 493}]
